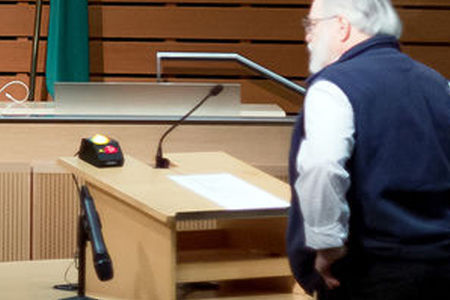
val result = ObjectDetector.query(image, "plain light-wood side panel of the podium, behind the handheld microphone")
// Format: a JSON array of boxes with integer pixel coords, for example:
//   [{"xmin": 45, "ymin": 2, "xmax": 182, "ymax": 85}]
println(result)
[{"xmin": 86, "ymin": 185, "xmax": 176, "ymax": 300}]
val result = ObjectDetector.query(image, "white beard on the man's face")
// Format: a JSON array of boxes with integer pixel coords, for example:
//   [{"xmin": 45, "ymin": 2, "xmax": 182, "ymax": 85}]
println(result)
[{"xmin": 308, "ymin": 34, "xmax": 334, "ymax": 74}]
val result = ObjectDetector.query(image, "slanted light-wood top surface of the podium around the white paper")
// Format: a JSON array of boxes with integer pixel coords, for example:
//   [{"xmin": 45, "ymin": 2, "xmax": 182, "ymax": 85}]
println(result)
[{"xmin": 59, "ymin": 152, "xmax": 290, "ymax": 223}]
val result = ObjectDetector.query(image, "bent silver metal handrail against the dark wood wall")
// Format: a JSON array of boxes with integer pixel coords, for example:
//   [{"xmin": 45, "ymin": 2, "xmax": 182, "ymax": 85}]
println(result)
[{"xmin": 156, "ymin": 52, "xmax": 306, "ymax": 95}]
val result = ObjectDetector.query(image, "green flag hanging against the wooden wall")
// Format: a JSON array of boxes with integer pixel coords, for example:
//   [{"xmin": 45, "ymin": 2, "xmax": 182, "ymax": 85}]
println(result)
[{"xmin": 46, "ymin": 0, "xmax": 89, "ymax": 96}]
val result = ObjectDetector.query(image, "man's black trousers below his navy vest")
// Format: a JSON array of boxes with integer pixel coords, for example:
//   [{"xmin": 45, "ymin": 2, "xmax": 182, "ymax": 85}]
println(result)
[{"xmin": 318, "ymin": 258, "xmax": 450, "ymax": 300}]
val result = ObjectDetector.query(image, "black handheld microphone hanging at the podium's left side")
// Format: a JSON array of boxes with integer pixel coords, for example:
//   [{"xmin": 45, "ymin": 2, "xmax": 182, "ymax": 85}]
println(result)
[{"xmin": 80, "ymin": 186, "xmax": 113, "ymax": 281}]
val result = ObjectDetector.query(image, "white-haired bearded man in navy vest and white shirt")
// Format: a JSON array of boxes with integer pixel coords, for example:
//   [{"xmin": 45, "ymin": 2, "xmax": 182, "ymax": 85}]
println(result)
[{"xmin": 287, "ymin": 0, "xmax": 450, "ymax": 300}]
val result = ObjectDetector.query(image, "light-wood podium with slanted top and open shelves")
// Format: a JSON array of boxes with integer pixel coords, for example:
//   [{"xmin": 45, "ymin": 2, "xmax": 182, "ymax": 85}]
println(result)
[{"xmin": 59, "ymin": 153, "xmax": 303, "ymax": 300}]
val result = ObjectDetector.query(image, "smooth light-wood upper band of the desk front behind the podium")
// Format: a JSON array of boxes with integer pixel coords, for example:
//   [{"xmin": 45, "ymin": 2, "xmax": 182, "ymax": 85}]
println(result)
[{"xmin": 0, "ymin": 122, "xmax": 292, "ymax": 177}]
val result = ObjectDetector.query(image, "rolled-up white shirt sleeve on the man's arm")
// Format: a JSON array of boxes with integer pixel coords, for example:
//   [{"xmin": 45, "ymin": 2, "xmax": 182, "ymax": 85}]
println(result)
[{"xmin": 295, "ymin": 80, "xmax": 355, "ymax": 249}]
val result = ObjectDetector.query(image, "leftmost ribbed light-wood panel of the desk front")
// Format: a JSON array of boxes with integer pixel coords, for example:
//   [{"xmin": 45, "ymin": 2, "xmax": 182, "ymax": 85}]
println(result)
[{"xmin": 0, "ymin": 162, "xmax": 31, "ymax": 261}]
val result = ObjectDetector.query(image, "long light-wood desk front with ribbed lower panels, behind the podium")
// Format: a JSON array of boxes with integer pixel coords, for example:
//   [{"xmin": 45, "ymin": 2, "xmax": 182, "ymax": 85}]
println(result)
[{"xmin": 0, "ymin": 116, "xmax": 295, "ymax": 261}]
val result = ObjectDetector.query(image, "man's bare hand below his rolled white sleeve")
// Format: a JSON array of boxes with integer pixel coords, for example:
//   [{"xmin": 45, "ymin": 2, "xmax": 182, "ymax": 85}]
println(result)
[{"xmin": 315, "ymin": 247, "xmax": 347, "ymax": 289}]
